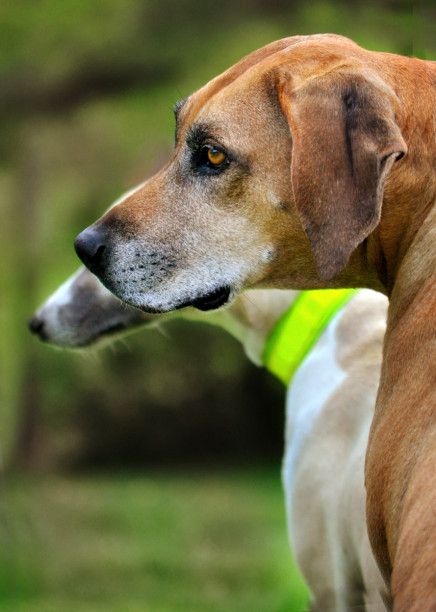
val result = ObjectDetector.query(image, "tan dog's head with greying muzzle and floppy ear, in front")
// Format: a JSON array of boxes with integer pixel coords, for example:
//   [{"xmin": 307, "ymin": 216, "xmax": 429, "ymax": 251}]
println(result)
[{"xmin": 75, "ymin": 35, "xmax": 407, "ymax": 312}]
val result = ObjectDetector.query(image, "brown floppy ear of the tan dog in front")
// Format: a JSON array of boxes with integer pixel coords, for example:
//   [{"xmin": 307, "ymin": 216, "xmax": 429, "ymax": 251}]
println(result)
[{"xmin": 278, "ymin": 72, "xmax": 407, "ymax": 280}]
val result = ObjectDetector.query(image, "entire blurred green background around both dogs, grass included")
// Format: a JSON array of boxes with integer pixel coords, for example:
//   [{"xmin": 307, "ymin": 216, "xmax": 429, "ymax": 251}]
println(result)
[{"xmin": 0, "ymin": 0, "xmax": 436, "ymax": 612}]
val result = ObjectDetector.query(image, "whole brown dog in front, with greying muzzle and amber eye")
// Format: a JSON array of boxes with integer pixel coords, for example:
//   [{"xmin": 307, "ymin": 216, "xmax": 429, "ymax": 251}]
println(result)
[{"xmin": 76, "ymin": 35, "xmax": 436, "ymax": 612}]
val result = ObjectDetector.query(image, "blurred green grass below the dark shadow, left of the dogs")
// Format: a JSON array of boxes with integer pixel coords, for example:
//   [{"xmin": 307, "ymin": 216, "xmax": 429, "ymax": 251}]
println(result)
[{"xmin": 0, "ymin": 469, "xmax": 307, "ymax": 612}]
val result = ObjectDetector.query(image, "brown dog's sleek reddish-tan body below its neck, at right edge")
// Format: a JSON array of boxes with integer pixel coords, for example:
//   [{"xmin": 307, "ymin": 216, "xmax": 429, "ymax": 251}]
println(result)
[{"xmin": 367, "ymin": 164, "xmax": 436, "ymax": 596}]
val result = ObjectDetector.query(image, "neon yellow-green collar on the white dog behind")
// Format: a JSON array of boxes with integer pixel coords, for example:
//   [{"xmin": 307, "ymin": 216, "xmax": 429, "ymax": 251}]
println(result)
[{"xmin": 262, "ymin": 289, "xmax": 358, "ymax": 385}]
